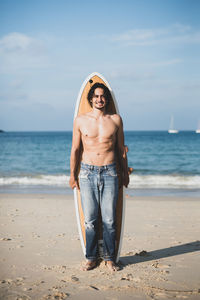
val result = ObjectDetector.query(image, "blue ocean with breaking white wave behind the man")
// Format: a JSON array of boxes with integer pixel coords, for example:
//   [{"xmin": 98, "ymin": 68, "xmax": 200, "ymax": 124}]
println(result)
[{"xmin": 0, "ymin": 131, "xmax": 200, "ymax": 197}]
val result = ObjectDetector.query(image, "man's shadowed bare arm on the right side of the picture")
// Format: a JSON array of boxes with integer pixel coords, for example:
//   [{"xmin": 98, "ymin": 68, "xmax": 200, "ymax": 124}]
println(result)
[{"xmin": 116, "ymin": 116, "xmax": 129, "ymax": 187}]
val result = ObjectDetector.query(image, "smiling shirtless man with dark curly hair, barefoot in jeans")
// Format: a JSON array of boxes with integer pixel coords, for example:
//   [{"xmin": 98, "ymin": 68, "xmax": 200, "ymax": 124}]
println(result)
[{"xmin": 69, "ymin": 83, "xmax": 129, "ymax": 271}]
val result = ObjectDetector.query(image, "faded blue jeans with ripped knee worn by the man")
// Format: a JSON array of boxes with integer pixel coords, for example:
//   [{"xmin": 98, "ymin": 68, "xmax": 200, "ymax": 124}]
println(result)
[{"xmin": 79, "ymin": 163, "xmax": 118, "ymax": 261}]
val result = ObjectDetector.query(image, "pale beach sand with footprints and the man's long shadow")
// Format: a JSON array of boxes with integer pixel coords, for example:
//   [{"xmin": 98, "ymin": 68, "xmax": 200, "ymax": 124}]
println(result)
[{"xmin": 0, "ymin": 194, "xmax": 200, "ymax": 300}]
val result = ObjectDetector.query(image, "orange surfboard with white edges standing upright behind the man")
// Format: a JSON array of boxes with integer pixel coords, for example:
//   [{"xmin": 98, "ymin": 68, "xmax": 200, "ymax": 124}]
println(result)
[{"xmin": 74, "ymin": 72, "xmax": 125, "ymax": 262}]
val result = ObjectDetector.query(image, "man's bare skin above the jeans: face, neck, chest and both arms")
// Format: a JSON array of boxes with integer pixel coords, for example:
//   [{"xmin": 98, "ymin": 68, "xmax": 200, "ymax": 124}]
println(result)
[{"xmin": 69, "ymin": 84, "xmax": 129, "ymax": 189}]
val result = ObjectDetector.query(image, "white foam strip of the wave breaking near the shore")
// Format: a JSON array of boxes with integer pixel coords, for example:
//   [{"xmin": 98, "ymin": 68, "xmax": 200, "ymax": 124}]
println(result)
[{"xmin": 0, "ymin": 174, "xmax": 200, "ymax": 189}]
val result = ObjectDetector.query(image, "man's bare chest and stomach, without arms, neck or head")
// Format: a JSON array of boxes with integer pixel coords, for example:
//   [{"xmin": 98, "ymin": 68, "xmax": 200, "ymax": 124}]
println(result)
[{"xmin": 79, "ymin": 113, "xmax": 119, "ymax": 166}]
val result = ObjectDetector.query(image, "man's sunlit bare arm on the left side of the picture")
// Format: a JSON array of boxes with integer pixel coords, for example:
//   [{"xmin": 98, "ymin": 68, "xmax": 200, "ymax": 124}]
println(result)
[{"xmin": 69, "ymin": 118, "xmax": 81, "ymax": 189}]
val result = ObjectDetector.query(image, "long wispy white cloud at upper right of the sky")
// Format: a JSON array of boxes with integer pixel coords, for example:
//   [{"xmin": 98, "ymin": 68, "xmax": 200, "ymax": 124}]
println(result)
[{"xmin": 110, "ymin": 24, "xmax": 200, "ymax": 46}]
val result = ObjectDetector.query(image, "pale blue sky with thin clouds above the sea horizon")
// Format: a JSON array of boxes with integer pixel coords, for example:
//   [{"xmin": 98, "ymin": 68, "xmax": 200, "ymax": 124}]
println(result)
[{"xmin": 0, "ymin": 0, "xmax": 200, "ymax": 131}]
